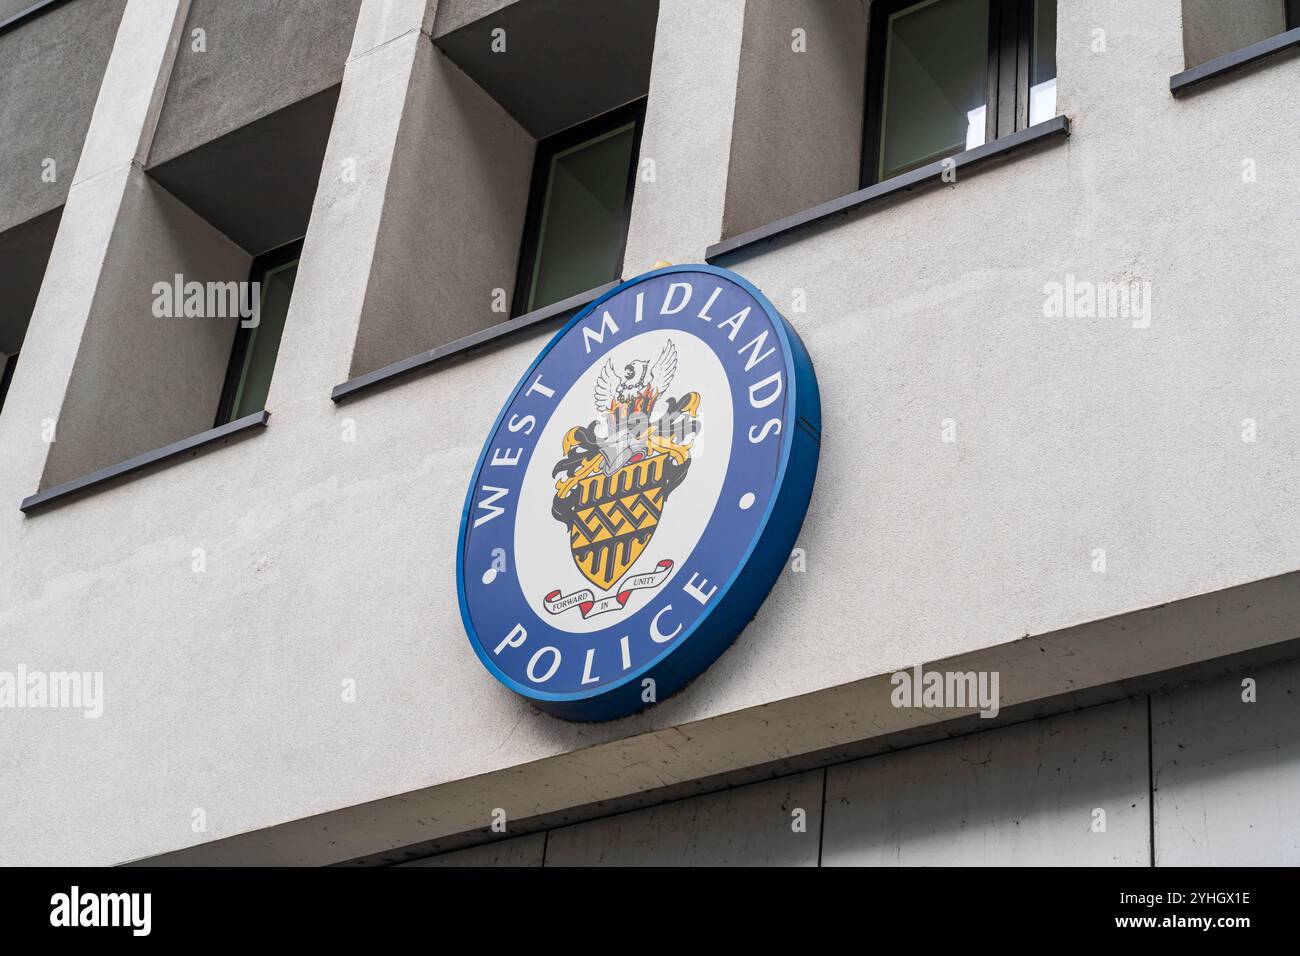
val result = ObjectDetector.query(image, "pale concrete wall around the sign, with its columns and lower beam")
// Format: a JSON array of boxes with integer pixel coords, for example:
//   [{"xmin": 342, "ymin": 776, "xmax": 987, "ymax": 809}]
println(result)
[{"xmin": 0, "ymin": 0, "xmax": 1300, "ymax": 862}]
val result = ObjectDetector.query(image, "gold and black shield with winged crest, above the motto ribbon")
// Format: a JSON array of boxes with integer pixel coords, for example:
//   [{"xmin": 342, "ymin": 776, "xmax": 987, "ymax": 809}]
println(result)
[{"xmin": 551, "ymin": 342, "xmax": 699, "ymax": 591}]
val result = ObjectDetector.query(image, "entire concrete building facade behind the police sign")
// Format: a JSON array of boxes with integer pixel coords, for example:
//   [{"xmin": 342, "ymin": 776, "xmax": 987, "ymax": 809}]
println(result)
[{"xmin": 0, "ymin": 0, "xmax": 1300, "ymax": 866}]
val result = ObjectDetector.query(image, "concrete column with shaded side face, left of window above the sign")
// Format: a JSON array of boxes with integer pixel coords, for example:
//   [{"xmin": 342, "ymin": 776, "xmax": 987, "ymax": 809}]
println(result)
[{"xmin": 268, "ymin": 0, "xmax": 533, "ymax": 400}]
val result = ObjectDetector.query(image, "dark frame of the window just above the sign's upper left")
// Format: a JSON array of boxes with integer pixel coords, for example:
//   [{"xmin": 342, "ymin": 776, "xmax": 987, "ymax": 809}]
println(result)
[{"xmin": 510, "ymin": 96, "xmax": 646, "ymax": 319}]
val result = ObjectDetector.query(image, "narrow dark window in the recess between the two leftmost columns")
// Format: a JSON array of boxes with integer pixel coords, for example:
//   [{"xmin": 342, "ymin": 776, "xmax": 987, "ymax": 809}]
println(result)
[{"xmin": 216, "ymin": 239, "xmax": 303, "ymax": 425}]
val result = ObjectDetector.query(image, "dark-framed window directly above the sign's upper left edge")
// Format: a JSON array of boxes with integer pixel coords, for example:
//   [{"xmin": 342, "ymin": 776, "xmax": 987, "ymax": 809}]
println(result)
[{"xmin": 515, "ymin": 99, "xmax": 645, "ymax": 316}]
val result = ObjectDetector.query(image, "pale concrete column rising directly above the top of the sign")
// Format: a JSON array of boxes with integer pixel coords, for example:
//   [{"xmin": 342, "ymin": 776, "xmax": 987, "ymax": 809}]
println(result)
[{"xmin": 623, "ymin": 0, "xmax": 745, "ymax": 276}]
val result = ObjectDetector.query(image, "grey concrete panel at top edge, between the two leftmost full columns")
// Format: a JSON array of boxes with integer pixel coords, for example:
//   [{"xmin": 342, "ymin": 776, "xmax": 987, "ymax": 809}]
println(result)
[{"xmin": 148, "ymin": 0, "xmax": 361, "ymax": 165}]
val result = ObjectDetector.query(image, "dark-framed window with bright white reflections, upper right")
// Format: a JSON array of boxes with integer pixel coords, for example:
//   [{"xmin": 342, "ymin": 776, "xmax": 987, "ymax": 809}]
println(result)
[{"xmin": 862, "ymin": 0, "xmax": 1056, "ymax": 186}]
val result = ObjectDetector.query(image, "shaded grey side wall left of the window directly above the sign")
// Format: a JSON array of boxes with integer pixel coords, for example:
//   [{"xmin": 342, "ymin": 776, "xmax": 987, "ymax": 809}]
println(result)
[{"xmin": 348, "ymin": 39, "xmax": 534, "ymax": 376}]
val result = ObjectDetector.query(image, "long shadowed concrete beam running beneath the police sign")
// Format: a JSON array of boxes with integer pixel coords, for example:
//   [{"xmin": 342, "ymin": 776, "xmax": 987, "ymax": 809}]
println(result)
[{"xmin": 140, "ymin": 572, "xmax": 1300, "ymax": 865}]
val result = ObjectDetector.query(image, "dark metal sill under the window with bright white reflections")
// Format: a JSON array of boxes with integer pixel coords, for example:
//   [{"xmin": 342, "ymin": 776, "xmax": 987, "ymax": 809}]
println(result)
[{"xmin": 705, "ymin": 116, "xmax": 1070, "ymax": 263}]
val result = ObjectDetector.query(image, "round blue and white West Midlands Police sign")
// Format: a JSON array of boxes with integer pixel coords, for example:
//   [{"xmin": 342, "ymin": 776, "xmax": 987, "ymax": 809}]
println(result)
[{"xmin": 456, "ymin": 265, "xmax": 822, "ymax": 721}]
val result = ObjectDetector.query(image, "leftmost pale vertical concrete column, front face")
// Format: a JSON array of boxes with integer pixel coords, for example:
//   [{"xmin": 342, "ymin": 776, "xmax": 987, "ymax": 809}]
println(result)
[{"xmin": 0, "ymin": 0, "xmax": 189, "ymax": 509}]
